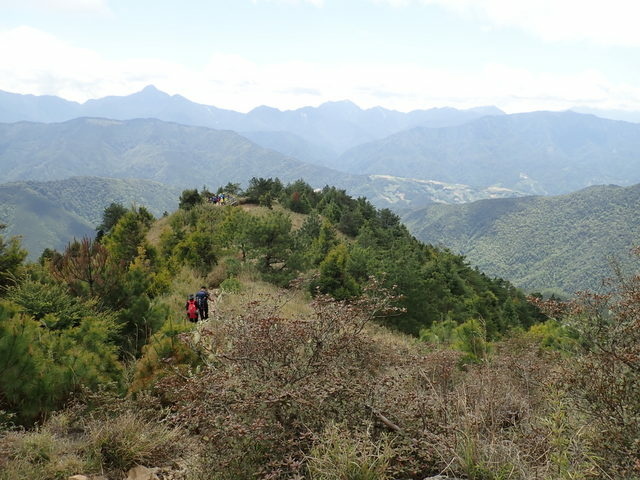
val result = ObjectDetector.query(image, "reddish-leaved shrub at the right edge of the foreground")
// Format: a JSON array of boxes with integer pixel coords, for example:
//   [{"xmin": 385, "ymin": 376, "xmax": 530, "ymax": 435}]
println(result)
[{"xmin": 534, "ymin": 253, "xmax": 640, "ymax": 478}]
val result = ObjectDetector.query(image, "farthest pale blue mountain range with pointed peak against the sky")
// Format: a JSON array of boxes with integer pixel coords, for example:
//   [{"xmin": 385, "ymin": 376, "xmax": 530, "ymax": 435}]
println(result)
[{"xmin": 0, "ymin": 86, "xmax": 504, "ymax": 156}]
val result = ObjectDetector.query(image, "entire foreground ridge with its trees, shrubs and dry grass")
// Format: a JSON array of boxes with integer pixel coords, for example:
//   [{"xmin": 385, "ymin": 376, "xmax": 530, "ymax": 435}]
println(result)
[{"xmin": 0, "ymin": 178, "xmax": 640, "ymax": 480}]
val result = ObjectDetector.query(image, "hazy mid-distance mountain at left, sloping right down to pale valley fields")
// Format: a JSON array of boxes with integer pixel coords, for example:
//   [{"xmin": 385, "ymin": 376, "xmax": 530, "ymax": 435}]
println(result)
[{"xmin": 0, "ymin": 118, "xmax": 518, "ymax": 209}]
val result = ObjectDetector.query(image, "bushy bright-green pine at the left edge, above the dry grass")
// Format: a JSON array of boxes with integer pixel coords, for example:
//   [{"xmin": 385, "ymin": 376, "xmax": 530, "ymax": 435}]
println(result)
[{"xmin": 0, "ymin": 303, "xmax": 122, "ymax": 424}]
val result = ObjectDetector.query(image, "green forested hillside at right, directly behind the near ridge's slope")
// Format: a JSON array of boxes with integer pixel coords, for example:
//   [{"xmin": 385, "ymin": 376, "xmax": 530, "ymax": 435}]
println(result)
[{"xmin": 403, "ymin": 185, "xmax": 640, "ymax": 293}]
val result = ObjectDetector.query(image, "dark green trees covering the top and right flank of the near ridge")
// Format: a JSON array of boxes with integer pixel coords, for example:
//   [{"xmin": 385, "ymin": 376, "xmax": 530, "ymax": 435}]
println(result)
[{"xmin": 169, "ymin": 178, "xmax": 531, "ymax": 335}]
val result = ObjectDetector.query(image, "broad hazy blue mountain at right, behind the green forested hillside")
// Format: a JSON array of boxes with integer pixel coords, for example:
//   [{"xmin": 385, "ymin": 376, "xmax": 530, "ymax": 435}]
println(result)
[{"xmin": 339, "ymin": 112, "xmax": 640, "ymax": 194}]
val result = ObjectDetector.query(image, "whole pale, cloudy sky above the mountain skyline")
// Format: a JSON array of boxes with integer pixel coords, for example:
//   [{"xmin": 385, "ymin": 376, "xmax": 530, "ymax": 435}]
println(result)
[{"xmin": 0, "ymin": 0, "xmax": 640, "ymax": 113}]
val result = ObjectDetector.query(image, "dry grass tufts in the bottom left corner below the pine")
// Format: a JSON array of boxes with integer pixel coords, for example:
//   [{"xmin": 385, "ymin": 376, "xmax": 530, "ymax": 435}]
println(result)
[{"xmin": 0, "ymin": 408, "xmax": 194, "ymax": 480}]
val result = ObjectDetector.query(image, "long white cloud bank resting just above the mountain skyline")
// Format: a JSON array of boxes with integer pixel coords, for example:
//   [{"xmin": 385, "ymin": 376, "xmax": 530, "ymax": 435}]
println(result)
[{"xmin": 0, "ymin": 27, "xmax": 640, "ymax": 112}]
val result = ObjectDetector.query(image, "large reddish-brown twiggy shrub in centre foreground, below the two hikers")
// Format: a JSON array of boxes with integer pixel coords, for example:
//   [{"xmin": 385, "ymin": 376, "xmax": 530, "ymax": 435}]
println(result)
[{"xmin": 159, "ymin": 280, "xmax": 398, "ymax": 479}]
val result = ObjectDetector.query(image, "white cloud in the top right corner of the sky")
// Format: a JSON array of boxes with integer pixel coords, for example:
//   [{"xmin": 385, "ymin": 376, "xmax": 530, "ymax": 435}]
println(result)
[{"xmin": 373, "ymin": 0, "xmax": 640, "ymax": 46}]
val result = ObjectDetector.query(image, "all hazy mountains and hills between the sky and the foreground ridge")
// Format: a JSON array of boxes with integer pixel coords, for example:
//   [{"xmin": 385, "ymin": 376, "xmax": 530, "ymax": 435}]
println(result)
[{"xmin": 0, "ymin": 87, "xmax": 640, "ymax": 291}]
